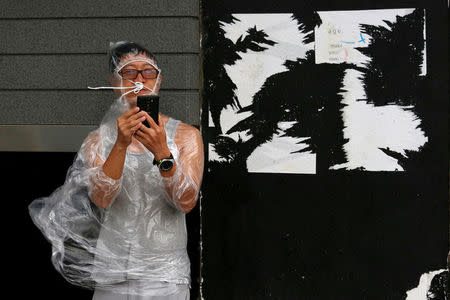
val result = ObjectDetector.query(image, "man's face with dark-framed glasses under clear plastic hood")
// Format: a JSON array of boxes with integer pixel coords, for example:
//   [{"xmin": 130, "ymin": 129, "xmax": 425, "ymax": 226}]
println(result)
[{"xmin": 111, "ymin": 54, "xmax": 162, "ymax": 103}]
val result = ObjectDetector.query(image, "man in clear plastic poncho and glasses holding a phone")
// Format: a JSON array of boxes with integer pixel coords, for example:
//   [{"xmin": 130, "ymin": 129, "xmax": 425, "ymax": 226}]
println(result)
[{"xmin": 30, "ymin": 42, "xmax": 204, "ymax": 300}]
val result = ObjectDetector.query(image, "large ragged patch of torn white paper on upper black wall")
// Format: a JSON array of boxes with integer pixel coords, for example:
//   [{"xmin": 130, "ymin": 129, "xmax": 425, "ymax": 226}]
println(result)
[{"xmin": 209, "ymin": 9, "xmax": 428, "ymax": 174}]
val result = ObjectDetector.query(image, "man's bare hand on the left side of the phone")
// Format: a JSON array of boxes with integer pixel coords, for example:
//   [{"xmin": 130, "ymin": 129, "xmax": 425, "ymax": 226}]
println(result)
[{"xmin": 116, "ymin": 107, "xmax": 145, "ymax": 148}]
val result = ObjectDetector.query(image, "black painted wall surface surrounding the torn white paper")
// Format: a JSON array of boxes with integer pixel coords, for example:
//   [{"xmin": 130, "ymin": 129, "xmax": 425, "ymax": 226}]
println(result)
[{"xmin": 202, "ymin": 0, "xmax": 449, "ymax": 300}]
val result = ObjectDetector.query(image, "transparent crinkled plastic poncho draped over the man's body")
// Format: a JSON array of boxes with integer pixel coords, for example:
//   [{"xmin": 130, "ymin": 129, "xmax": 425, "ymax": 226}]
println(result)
[{"xmin": 29, "ymin": 44, "xmax": 204, "ymax": 295}]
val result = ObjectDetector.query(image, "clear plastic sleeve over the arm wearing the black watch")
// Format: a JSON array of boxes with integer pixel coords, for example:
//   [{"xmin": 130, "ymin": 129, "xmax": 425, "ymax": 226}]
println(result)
[{"xmin": 162, "ymin": 123, "xmax": 204, "ymax": 213}]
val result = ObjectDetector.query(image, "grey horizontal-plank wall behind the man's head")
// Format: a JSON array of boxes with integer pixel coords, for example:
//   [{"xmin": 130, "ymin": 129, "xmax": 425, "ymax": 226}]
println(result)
[{"xmin": 0, "ymin": 0, "xmax": 200, "ymax": 151}]
